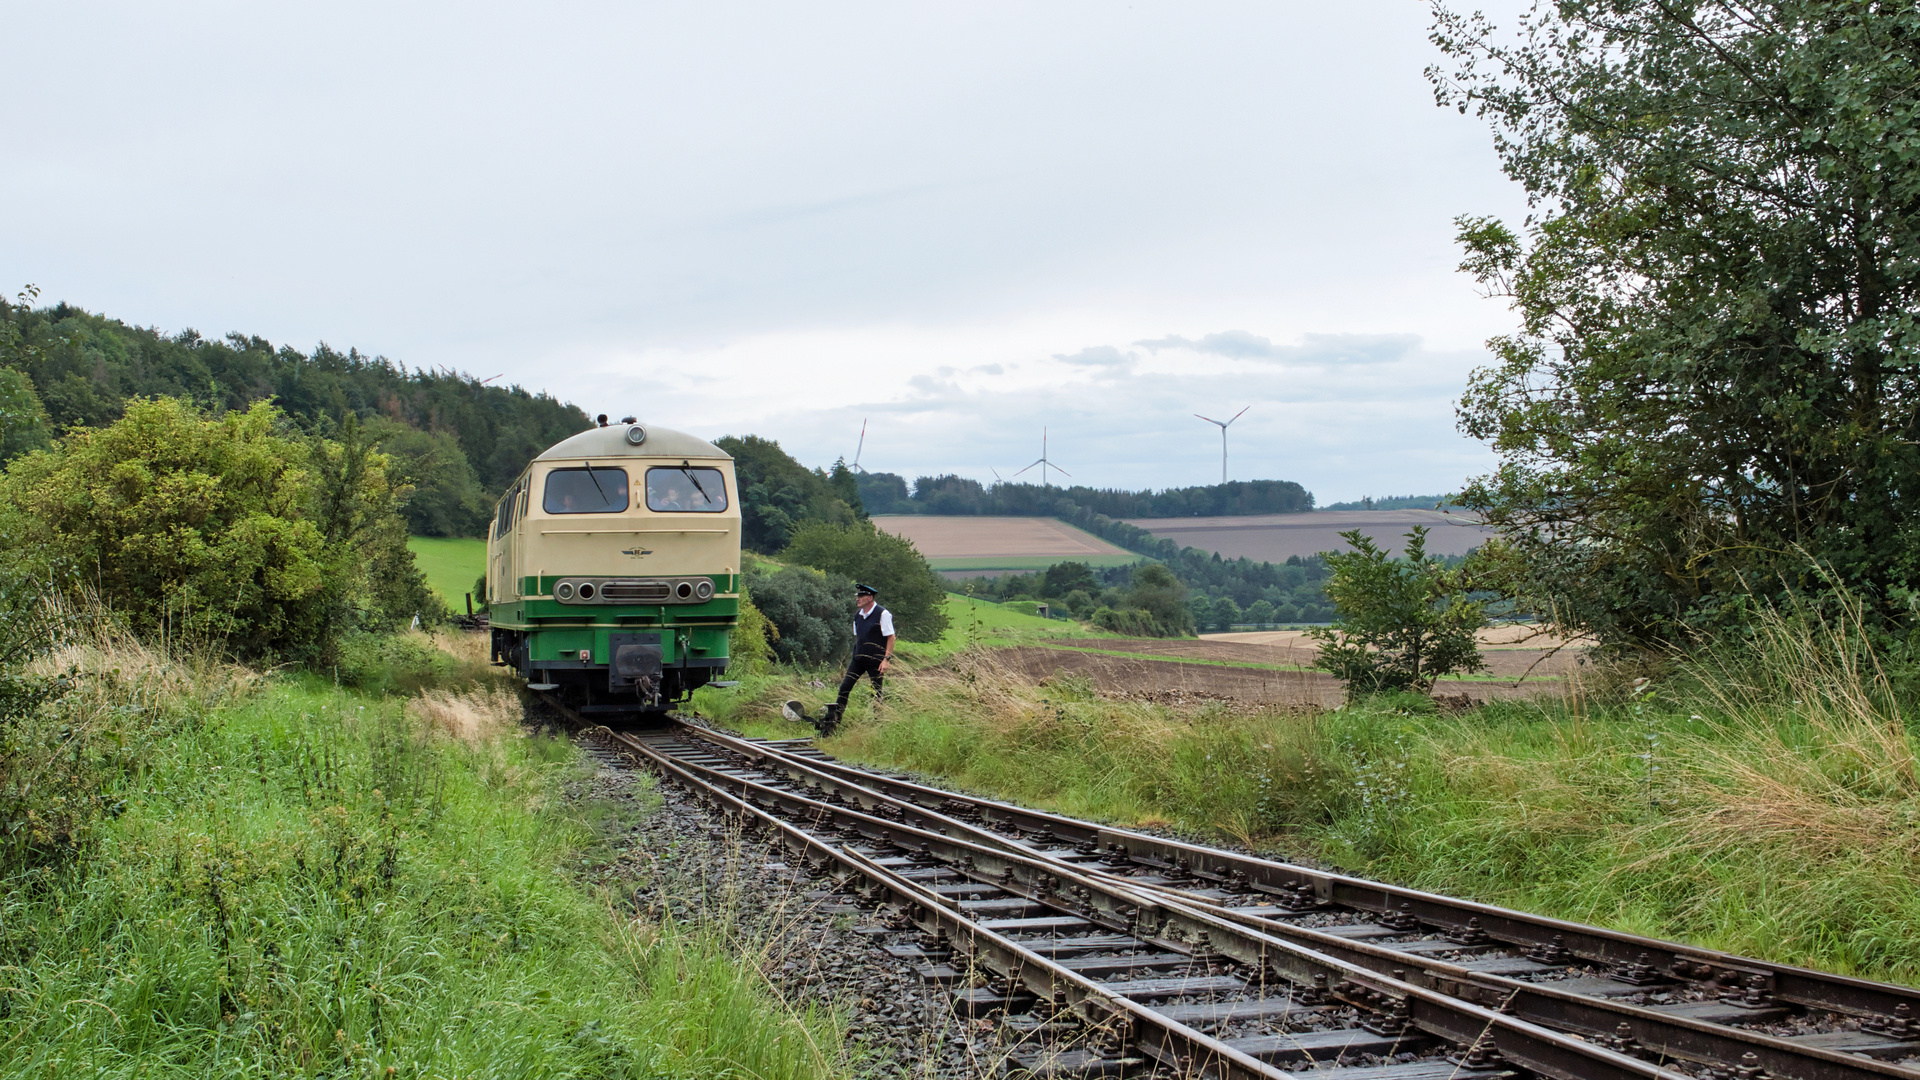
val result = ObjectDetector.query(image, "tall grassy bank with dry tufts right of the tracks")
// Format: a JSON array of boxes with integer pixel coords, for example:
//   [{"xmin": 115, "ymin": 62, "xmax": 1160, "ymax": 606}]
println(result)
[{"xmin": 721, "ymin": 607, "xmax": 1920, "ymax": 982}]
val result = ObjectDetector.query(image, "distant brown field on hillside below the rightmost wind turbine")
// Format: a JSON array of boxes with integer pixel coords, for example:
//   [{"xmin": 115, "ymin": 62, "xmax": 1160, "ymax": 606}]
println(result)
[{"xmin": 1129, "ymin": 509, "xmax": 1494, "ymax": 563}]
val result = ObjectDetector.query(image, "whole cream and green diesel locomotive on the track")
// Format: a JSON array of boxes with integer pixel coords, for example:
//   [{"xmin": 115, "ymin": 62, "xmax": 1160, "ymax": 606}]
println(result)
[{"xmin": 486, "ymin": 419, "xmax": 739, "ymax": 713}]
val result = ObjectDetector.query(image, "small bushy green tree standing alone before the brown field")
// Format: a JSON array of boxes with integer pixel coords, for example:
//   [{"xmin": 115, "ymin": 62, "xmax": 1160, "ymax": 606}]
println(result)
[{"xmin": 1308, "ymin": 525, "xmax": 1486, "ymax": 694}]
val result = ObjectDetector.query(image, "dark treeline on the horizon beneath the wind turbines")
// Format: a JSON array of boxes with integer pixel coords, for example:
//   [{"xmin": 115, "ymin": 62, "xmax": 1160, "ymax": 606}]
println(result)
[{"xmin": 858, "ymin": 473, "xmax": 1313, "ymax": 517}]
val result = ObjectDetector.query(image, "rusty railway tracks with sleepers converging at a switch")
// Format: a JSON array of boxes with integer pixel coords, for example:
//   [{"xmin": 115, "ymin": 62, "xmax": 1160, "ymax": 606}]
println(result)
[{"xmin": 555, "ymin": 703, "xmax": 1920, "ymax": 1080}]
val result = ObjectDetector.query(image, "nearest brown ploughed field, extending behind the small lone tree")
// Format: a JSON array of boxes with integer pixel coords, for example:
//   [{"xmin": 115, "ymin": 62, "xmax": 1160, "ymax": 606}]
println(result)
[{"xmin": 996, "ymin": 626, "xmax": 1584, "ymax": 707}]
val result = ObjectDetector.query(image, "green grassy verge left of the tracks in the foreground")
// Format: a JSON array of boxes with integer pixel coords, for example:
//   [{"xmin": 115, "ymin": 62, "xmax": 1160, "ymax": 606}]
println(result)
[{"xmin": 0, "ymin": 622, "xmax": 843, "ymax": 1078}]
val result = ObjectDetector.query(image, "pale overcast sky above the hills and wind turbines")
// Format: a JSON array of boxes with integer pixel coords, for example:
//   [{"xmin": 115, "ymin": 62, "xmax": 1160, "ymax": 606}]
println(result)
[{"xmin": 0, "ymin": 0, "xmax": 1524, "ymax": 503}]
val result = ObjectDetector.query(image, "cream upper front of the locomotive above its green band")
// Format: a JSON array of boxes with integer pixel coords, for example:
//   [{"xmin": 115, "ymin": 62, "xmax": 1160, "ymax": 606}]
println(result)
[{"xmin": 518, "ymin": 425, "xmax": 741, "ymax": 577}]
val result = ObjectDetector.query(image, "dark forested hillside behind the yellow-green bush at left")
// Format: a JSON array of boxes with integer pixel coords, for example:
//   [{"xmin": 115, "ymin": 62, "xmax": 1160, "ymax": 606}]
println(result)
[{"xmin": 0, "ymin": 296, "xmax": 588, "ymax": 536}]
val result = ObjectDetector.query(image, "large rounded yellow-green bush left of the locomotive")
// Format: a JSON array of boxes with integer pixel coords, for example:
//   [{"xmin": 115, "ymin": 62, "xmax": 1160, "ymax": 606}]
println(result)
[{"xmin": 0, "ymin": 390, "xmax": 444, "ymax": 659}]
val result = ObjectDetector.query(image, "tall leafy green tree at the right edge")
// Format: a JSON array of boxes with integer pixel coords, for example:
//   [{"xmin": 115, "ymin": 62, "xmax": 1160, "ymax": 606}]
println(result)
[{"xmin": 1428, "ymin": 0, "xmax": 1920, "ymax": 644}]
